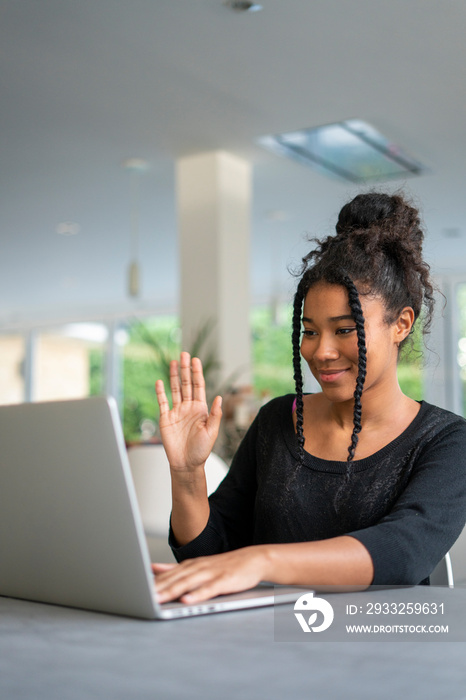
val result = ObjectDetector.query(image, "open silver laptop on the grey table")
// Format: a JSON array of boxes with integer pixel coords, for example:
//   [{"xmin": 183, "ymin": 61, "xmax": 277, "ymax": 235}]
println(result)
[{"xmin": 0, "ymin": 397, "xmax": 302, "ymax": 619}]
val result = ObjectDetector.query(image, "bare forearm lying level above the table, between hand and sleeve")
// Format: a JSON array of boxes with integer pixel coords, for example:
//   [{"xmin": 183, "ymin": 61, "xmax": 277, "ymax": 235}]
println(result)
[{"xmin": 264, "ymin": 535, "xmax": 374, "ymax": 587}]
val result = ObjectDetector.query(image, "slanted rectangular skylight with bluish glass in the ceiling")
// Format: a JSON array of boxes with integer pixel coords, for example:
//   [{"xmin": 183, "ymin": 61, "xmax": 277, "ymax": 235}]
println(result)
[{"xmin": 258, "ymin": 119, "xmax": 426, "ymax": 183}]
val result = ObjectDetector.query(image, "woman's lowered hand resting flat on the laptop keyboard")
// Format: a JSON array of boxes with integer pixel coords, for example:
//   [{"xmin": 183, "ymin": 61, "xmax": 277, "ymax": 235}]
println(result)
[{"xmin": 152, "ymin": 545, "xmax": 268, "ymax": 603}]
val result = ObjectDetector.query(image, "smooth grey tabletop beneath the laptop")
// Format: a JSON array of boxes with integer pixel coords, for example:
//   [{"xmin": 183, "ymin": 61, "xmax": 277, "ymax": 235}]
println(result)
[{"xmin": 0, "ymin": 589, "xmax": 466, "ymax": 700}]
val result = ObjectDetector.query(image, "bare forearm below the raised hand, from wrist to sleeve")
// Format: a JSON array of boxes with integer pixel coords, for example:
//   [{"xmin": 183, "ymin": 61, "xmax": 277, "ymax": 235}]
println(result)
[{"xmin": 170, "ymin": 467, "xmax": 210, "ymax": 546}]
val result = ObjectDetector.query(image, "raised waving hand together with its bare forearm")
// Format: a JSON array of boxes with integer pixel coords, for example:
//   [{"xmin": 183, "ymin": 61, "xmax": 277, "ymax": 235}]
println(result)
[{"xmin": 155, "ymin": 352, "xmax": 222, "ymax": 546}]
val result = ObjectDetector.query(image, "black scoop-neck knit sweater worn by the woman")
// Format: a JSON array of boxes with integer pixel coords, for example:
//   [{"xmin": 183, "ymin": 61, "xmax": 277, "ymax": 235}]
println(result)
[{"xmin": 170, "ymin": 394, "xmax": 466, "ymax": 585}]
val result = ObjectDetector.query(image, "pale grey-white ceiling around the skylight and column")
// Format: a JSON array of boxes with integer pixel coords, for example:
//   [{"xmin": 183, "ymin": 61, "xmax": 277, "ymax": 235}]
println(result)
[{"xmin": 0, "ymin": 0, "xmax": 466, "ymax": 327}]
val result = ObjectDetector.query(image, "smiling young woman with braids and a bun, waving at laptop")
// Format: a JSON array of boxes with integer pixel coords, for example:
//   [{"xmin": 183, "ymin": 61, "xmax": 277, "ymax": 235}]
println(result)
[{"xmin": 153, "ymin": 194, "xmax": 466, "ymax": 603}]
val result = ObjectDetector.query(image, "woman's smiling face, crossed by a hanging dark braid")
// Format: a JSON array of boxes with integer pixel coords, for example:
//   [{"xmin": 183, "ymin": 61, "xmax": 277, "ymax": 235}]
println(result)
[{"xmin": 301, "ymin": 282, "xmax": 412, "ymax": 402}]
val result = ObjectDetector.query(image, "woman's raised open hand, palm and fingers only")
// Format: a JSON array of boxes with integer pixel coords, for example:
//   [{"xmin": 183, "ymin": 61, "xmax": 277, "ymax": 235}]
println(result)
[{"xmin": 155, "ymin": 352, "xmax": 222, "ymax": 472}]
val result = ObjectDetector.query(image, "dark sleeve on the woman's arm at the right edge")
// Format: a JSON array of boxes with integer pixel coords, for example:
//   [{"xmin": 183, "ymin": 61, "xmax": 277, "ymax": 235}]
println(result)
[{"xmin": 348, "ymin": 423, "xmax": 466, "ymax": 585}]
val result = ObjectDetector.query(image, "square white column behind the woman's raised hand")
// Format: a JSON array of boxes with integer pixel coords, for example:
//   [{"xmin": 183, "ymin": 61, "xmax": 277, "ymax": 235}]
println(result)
[{"xmin": 176, "ymin": 151, "xmax": 251, "ymax": 385}]
